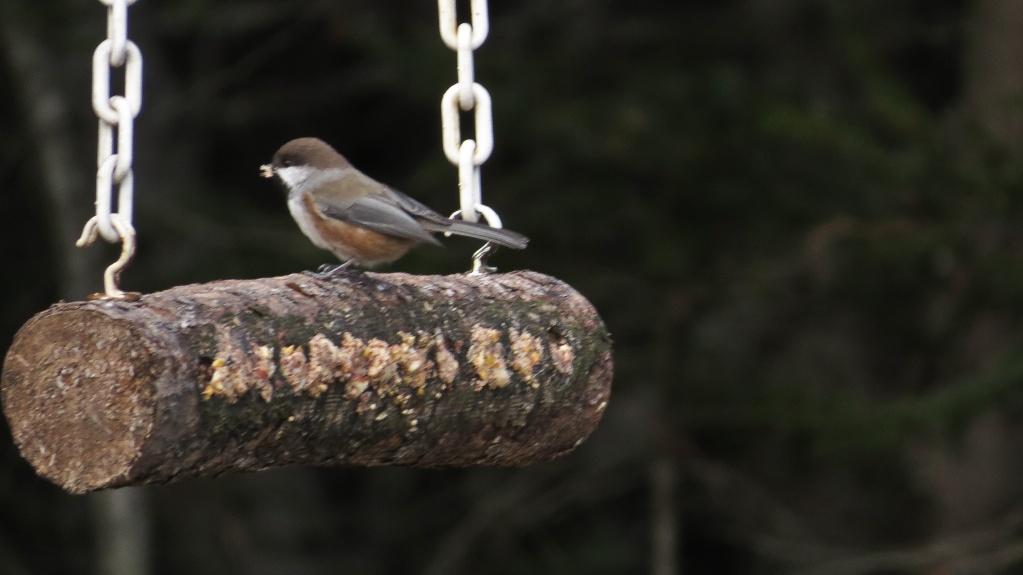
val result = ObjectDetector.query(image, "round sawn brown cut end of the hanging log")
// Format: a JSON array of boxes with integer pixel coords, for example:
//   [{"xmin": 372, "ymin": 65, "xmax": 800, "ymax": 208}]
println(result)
[{"xmin": 2, "ymin": 306, "xmax": 157, "ymax": 493}]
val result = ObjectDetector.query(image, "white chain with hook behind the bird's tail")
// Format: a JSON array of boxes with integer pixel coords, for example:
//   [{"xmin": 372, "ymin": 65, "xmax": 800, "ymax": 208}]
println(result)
[{"xmin": 438, "ymin": 0, "xmax": 501, "ymax": 273}]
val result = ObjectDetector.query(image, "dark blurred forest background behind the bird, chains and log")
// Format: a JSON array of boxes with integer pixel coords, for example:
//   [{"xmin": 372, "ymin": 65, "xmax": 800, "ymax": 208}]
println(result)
[{"xmin": 6, "ymin": 0, "xmax": 1023, "ymax": 575}]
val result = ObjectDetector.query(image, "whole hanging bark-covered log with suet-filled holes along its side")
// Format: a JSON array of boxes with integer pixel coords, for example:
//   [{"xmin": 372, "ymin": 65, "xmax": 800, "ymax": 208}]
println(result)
[{"xmin": 0, "ymin": 271, "xmax": 613, "ymax": 493}]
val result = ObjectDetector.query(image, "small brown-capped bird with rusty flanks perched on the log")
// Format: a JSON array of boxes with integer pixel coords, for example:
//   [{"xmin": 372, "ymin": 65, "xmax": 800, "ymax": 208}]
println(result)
[{"xmin": 260, "ymin": 138, "xmax": 529, "ymax": 273}]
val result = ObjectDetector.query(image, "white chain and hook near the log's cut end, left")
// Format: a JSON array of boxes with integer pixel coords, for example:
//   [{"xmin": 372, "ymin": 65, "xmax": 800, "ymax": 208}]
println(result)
[{"xmin": 76, "ymin": 0, "xmax": 142, "ymax": 299}]
